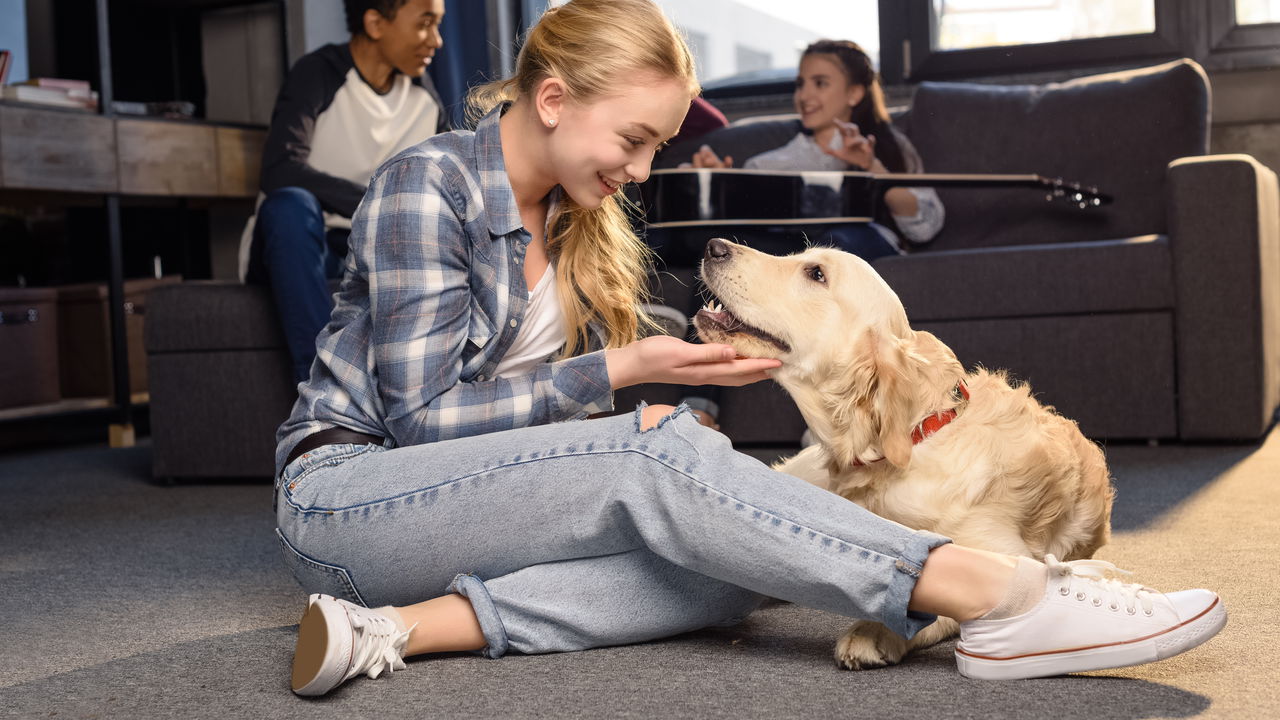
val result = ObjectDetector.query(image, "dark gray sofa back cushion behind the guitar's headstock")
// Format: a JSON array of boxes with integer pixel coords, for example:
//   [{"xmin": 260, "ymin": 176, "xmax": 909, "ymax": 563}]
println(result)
[{"xmin": 902, "ymin": 60, "xmax": 1210, "ymax": 250}]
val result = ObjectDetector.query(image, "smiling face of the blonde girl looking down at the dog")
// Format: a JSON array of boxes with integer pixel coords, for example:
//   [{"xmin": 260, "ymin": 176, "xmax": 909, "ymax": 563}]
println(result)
[{"xmin": 548, "ymin": 74, "xmax": 690, "ymax": 210}]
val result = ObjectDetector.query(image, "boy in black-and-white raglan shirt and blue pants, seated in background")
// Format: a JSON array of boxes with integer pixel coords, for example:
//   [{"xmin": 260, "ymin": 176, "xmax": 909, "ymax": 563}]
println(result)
[{"xmin": 241, "ymin": 0, "xmax": 449, "ymax": 382}]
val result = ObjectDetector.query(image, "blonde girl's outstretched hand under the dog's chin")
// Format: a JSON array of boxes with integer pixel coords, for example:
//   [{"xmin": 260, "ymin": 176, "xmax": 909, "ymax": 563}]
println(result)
[{"xmin": 604, "ymin": 336, "xmax": 782, "ymax": 389}]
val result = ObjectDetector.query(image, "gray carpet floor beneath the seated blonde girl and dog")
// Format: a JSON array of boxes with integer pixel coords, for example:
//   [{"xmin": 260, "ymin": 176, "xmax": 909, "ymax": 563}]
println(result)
[{"xmin": 0, "ymin": 432, "xmax": 1280, "ymax": 720}]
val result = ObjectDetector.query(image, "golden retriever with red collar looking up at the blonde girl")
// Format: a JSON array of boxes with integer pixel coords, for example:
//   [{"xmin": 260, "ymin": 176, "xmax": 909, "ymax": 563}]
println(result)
[{"xmin": 694, "ymin": 240, "xmax": 1114, "ymax": 669}]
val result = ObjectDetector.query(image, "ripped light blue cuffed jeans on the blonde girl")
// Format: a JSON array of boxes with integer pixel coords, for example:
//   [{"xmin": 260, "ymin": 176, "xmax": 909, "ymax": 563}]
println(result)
[{"xmin": 276, "ymin": 406, "xmax": 947, "ymax": 657}]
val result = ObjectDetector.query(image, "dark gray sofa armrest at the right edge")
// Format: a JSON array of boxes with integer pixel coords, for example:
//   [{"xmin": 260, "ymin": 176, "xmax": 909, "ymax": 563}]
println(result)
[{"xmin": 1166, "ymin": 155, "xmax": 1280, "ymax": 439}]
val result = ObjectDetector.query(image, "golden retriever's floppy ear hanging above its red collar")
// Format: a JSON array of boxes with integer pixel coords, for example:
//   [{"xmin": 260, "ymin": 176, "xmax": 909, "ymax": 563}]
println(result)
[{"xmin": 828, "ymin": 329, "xmax": 916, "ymax": 468}]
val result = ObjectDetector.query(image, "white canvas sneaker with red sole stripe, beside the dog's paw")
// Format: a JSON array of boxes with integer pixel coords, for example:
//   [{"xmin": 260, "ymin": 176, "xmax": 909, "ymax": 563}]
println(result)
[{"xmin": 956, "ymin": 555, "xmax": 1226, "ymax": 680}]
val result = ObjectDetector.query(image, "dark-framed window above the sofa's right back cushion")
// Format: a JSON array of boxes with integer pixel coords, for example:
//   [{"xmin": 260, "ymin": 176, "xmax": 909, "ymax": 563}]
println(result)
[{"xmin": 879, "ymin": 0, "xmax": 1280, "ymax": 85}]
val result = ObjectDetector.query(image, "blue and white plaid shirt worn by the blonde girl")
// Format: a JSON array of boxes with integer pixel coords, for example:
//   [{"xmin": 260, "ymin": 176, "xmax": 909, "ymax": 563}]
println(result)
[{"xmin": 275, "ymin": 105, "xmax": 613, "ymax": 473}]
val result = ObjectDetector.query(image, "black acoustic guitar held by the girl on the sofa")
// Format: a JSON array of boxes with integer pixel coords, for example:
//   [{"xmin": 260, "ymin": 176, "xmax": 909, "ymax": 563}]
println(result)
[{"xmin": 640, "ymin": 168, "xmax": 1112, "ymax": 228}]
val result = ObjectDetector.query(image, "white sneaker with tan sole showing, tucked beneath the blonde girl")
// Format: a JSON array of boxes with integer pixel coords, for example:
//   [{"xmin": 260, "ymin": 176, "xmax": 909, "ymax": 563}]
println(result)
[{"xmin": 292, "ymin": 594, "xmax": 412, "ymax": 696}]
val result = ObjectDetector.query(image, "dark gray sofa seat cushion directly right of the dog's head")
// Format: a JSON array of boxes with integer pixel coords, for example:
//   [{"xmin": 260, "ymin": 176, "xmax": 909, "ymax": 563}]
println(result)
[{"xmin": 874, "ymin": 236, "xmax": 1174, "ymax": 317}]
